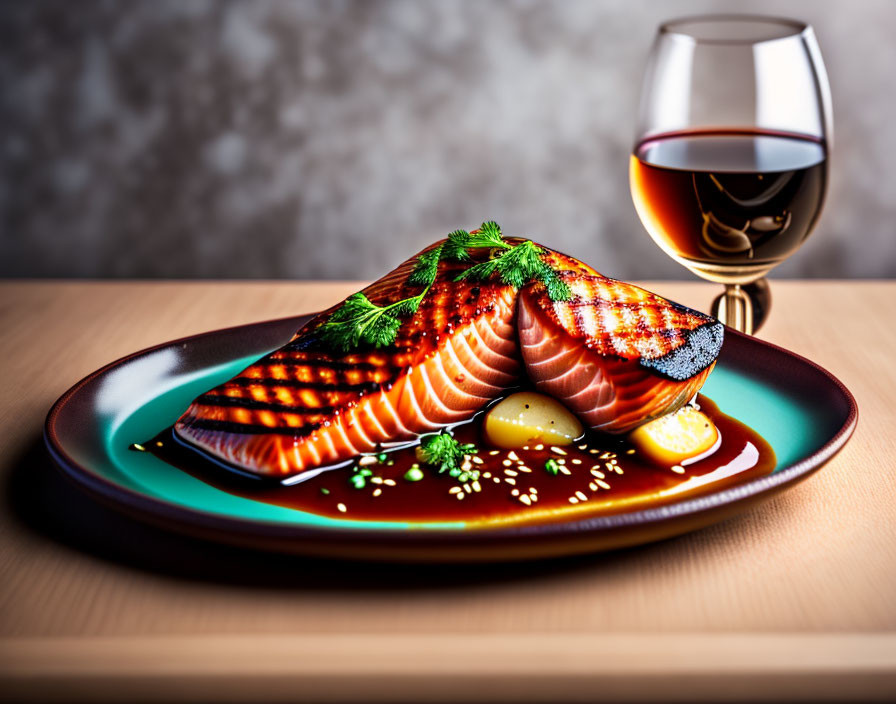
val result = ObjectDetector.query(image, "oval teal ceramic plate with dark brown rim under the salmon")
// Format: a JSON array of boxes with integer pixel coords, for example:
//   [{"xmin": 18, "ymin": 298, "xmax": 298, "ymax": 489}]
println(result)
[{"xmin": 45, "ymin": 316, "xmax": 857, "ymax": 561}]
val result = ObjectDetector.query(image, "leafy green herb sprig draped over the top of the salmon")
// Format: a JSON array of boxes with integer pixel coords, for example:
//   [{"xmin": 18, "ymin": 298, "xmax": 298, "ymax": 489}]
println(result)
[{"xmin": 316, "ymin": 221, "xmax": 571, "ymax": 352}]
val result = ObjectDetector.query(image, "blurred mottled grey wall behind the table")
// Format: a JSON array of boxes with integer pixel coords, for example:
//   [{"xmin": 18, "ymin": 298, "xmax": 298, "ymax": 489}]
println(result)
[{"xmin": 0, "ymin": 0, "xmax": 896, "ymax": 278}]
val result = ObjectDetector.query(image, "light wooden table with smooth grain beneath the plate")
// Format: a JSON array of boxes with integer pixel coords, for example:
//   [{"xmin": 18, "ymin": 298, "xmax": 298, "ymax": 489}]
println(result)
[{"xmin": 0, "ymin": 281, "xmax": 896, "ymax": 702}]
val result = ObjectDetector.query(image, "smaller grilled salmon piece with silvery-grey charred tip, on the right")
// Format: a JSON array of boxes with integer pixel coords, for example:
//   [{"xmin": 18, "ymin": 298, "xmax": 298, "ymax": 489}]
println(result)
[{"xmin": 518, "ymin": 273, "xmax": 724, "ymax": 433}]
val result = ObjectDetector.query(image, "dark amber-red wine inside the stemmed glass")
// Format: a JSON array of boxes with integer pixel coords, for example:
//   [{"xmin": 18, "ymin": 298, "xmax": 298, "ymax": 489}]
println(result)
[{"xmin": 630, "ymin": 129, "xmax": 827, "ymax": 283}]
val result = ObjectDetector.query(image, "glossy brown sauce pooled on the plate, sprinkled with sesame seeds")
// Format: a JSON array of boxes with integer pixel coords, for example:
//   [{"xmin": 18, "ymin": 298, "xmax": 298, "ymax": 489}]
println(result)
[{"xmin": 143, "ymin": 396, "xmax": 775, "ymax": 527}]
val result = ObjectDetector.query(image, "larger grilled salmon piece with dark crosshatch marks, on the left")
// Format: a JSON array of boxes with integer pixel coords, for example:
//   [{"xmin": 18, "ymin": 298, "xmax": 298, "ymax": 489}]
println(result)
[{"xmin": 175, "ymin": 240, "xmax": 596, "ymax": 477}]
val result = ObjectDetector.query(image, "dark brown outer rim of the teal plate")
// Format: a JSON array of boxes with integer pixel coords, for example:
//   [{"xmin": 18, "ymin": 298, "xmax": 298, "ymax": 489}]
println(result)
[{"xmin": 44, "ymin": 314, "xmax": 858, "ymax": 547}]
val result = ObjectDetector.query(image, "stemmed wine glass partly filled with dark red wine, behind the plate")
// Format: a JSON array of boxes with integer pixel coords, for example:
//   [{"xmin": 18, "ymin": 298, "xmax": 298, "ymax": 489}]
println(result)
[{"xmin": 630, "ymin": 15, "xmax": 831, "ymax": 333}]
